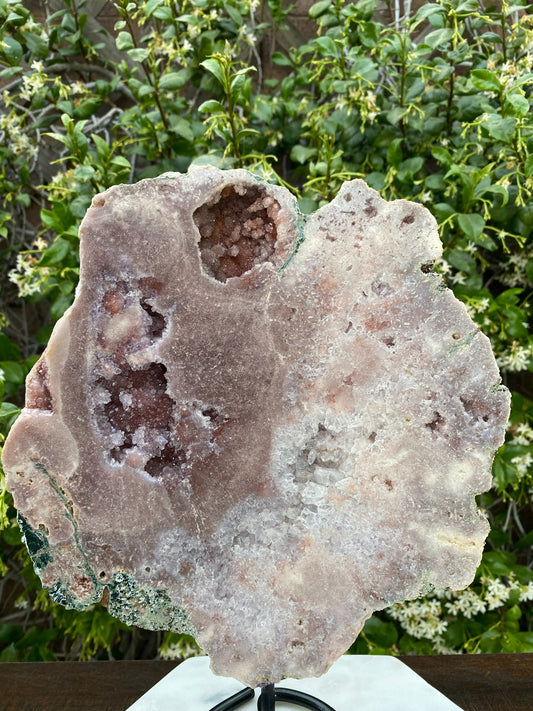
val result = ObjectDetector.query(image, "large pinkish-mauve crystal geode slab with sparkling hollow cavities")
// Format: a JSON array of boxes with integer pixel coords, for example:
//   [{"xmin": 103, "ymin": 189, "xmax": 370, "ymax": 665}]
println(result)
[{"xmin": 3, "ymin": 168, "xmax": 509, "ymax": 686}]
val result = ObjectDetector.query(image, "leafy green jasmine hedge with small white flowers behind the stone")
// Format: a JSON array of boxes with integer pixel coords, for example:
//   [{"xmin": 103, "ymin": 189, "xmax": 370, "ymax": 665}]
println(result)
[{"xmin": 0, "ymin": 0, "xmax": 533, "ymax": 661}]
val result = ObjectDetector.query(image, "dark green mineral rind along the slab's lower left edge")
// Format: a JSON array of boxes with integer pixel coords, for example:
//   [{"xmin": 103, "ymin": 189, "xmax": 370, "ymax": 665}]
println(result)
[{"xmin": 17, "ymin": 462, "xmax": 194, "ymax": 636}]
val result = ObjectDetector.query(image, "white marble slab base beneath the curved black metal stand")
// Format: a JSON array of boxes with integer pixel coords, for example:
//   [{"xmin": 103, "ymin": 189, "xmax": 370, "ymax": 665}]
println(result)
[{"xmin": 128, "ymin": 655, "xmax": 461, "ymax": 711}]
